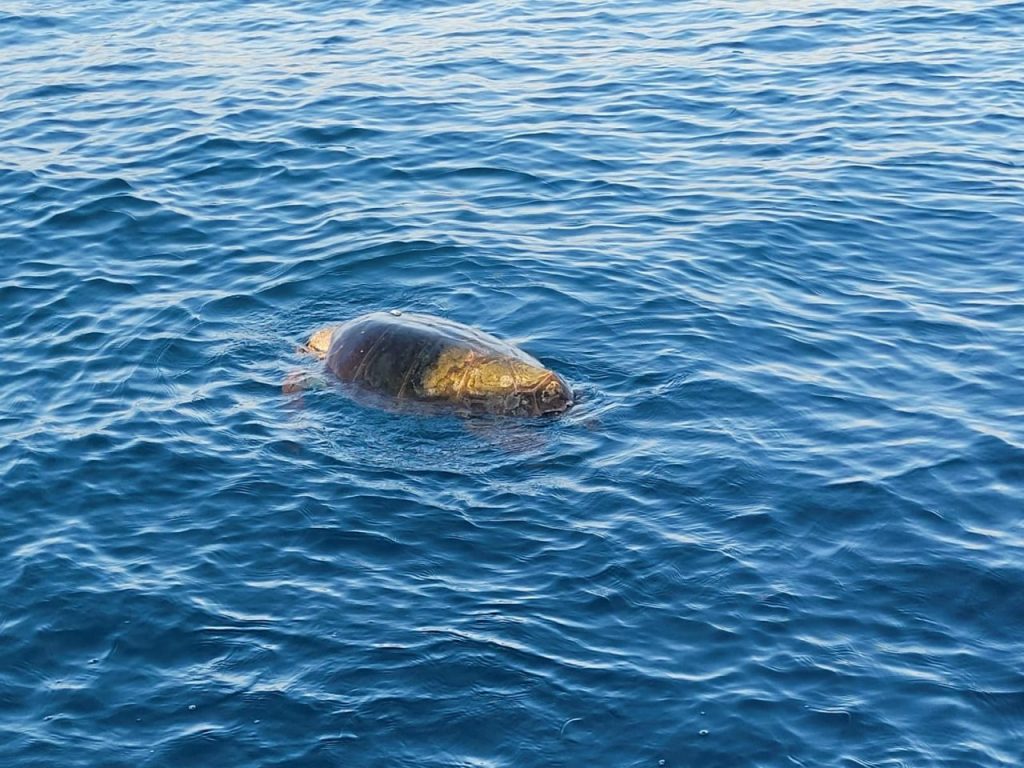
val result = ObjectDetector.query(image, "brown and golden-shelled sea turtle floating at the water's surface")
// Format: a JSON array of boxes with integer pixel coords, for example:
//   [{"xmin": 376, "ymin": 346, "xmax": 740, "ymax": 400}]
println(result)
[{"xmin": 292, "ymin": 311, "xmax": 572, "ymax": 416}]
